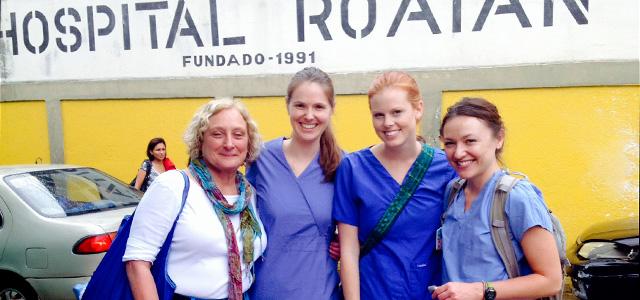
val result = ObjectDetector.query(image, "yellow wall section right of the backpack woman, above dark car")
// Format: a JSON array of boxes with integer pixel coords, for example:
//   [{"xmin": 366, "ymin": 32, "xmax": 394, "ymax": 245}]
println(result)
[{"xmin": 442, "ymin": 86, "xmax": 640, "ymax": 243}]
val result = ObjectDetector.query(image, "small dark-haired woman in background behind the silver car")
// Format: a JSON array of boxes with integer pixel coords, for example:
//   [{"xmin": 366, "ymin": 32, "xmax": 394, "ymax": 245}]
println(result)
[{"xmin": 134, "ymin": 137, "xmax": 176, "ymax": 192}]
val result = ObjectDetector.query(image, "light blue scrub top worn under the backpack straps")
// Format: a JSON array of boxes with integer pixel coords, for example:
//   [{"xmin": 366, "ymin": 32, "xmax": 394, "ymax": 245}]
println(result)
[{"xmin": 442, "ymin": 170, "xmax": 553, "ymax": 283}]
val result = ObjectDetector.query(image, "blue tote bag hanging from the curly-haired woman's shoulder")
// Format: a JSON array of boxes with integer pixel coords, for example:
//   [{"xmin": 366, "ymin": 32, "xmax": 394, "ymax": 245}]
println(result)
[{"xmin": 82, "ymin": 171, "xmax": 189, "ymax": 300}]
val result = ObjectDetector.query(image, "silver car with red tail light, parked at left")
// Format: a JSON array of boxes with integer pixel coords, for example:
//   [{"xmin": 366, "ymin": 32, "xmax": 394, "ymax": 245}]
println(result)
[{"xmin": 0, "ymin": 165, "xmax": 142, "ymax": 300}]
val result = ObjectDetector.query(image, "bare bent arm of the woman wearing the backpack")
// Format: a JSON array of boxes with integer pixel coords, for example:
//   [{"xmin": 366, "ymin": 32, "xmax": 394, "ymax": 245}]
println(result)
[{"xmin": 434, "ymin": 226, "xmax": 562, "ymax": 300}]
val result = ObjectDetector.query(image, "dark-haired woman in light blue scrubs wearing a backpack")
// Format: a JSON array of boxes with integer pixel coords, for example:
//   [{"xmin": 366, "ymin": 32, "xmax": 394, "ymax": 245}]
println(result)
[{"xmin": 433, "ymin": 98, "xmax": 562, "ymax": 300}]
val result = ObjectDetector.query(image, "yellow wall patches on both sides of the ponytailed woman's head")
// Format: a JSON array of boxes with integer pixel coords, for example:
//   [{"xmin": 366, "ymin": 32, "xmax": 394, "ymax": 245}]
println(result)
[{"xmin": 241, "ymin": 95, "xmax": 379, "ymax": 152}]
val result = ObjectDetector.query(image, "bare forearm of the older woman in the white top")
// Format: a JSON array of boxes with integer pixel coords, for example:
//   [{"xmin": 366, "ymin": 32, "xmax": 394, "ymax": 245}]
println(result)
[{"xmin": 126, "ymin": 260, "xmax": 158, "ymax": 300}]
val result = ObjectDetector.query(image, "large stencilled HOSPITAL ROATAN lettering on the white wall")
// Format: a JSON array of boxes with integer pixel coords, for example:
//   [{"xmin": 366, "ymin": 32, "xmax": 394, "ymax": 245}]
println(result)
[{"xmin": 0, "ymin": 0, "xmax": 589, "ymax": 55}]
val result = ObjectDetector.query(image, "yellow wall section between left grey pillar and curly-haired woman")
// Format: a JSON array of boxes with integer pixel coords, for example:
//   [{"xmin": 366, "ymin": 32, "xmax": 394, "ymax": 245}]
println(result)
[{"xmin": 61, "ymin": 98, "xmax": 209, "ymax": 183}]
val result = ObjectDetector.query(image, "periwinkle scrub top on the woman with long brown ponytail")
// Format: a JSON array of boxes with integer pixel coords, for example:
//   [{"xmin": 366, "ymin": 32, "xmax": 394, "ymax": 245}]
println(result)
[{"xmin": 247, "ymin": 138, "xmax": 339, "ymax": 300}]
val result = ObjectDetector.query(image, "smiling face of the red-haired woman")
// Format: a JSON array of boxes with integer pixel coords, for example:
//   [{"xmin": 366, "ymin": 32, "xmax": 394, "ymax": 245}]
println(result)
[{"xmin": 369, "ymin": 88, "xmax": 422, "ymax": 148}]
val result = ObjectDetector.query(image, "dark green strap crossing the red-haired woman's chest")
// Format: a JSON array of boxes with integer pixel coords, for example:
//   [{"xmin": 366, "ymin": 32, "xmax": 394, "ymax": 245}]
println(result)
[{"xmin": 360, "ymin": 144, "xmax": 434, "ymax": 258}]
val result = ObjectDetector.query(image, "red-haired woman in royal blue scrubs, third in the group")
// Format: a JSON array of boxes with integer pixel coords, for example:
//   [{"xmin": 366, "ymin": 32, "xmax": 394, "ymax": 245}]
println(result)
[{"xmin": 333, "ymin": 72, "xmax": 454, "ymax": 299}]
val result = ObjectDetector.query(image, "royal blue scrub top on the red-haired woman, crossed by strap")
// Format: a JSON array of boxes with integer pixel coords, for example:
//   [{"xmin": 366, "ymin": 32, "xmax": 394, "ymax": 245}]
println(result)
[{"xmin": 336, "ymin": 148, "xmax": 455, "ymax": 299}]
